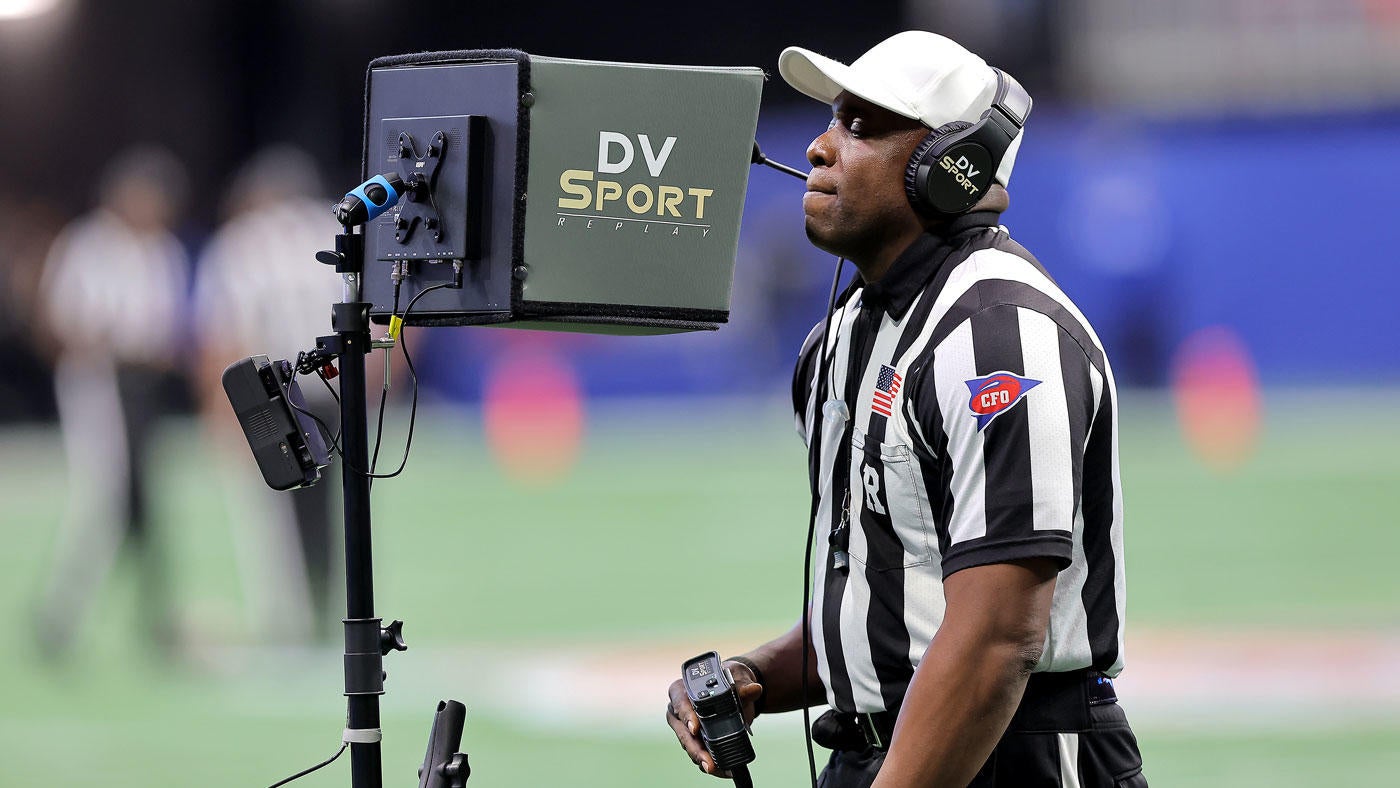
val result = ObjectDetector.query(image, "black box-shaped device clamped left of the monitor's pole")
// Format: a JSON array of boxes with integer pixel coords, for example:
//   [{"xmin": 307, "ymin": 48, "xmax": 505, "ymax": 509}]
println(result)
[{"xmin": 224, "ymin": 356, "xmax": 330, "ymax": 490}]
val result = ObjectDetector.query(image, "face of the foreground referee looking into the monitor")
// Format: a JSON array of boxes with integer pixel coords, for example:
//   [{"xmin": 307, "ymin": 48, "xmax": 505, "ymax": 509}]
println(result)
[{"xmin": 802, "ymin": 92, "xmax": 928, "ymax": 274}]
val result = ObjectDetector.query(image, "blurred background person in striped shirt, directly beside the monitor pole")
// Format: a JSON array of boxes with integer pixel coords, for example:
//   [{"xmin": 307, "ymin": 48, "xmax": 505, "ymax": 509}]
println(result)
[{"xmin": 195, "ymin": 147, "xmax": 340, "ymax": 642}]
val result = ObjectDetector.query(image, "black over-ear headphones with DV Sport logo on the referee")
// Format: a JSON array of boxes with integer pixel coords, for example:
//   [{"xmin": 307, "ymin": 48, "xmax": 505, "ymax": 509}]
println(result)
[{"xmin": 904, "ymin": 69, "xmax": 1030, "ymax": 217}]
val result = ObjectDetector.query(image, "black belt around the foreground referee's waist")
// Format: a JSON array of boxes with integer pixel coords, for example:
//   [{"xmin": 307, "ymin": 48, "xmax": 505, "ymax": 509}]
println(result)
[{"xmin": 812, "ymin": 670, "xmax": 1119, "ymax": 752}]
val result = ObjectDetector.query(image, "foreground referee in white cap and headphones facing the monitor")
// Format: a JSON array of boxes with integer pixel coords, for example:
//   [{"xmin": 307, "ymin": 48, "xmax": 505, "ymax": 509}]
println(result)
[{"xmin": 666, "ymin": 31, "xmax": 1147, "ymax": 788}]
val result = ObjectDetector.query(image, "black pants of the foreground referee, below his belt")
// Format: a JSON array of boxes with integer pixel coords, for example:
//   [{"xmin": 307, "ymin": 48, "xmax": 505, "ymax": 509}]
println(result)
[{"xmin": 818, "ymin": 679, "xmax": 1147, "ymax": 788}]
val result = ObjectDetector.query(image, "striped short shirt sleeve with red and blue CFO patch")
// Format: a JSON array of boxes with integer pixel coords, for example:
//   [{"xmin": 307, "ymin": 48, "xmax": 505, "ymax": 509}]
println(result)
[{"xmin": 910, "ymin": 304, "xmax": 1102, "ymax": 577}]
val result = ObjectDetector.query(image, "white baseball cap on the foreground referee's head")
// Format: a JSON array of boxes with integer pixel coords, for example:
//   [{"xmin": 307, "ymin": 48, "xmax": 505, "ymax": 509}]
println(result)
[{"xmin": 778, "ymin": 31, "xmax": 1022, "ymax": 183}]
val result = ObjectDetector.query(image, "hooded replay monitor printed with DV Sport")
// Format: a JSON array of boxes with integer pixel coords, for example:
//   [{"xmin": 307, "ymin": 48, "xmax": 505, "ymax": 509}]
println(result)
[{"xmin": 355, "ymin": 50, "xmax": 763, "ymax": 333}]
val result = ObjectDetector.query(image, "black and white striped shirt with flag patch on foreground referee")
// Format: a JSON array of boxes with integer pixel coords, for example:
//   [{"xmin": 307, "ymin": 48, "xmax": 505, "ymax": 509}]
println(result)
[{"xmin": 792, "ymin": 213, "xmax": 1124, "ymax": 711}]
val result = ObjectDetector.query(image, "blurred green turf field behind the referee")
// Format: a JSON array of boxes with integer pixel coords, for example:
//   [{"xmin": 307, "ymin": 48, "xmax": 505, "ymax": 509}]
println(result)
[{"xmin": 0, "ymin": 391, "xmax": 1400, "ymax": 788}]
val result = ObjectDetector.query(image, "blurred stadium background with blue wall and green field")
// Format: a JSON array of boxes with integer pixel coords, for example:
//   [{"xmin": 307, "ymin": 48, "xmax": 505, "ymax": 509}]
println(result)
[{"xmin": 0, "ymin": 0, "xmax": 1400, "ymax": 787}]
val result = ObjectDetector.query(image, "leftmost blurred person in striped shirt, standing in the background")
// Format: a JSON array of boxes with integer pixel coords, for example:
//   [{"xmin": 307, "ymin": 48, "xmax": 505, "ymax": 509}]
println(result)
[{"xmin": 36, "ymin": 147, "xmax": 189, "ymax": 655}]
